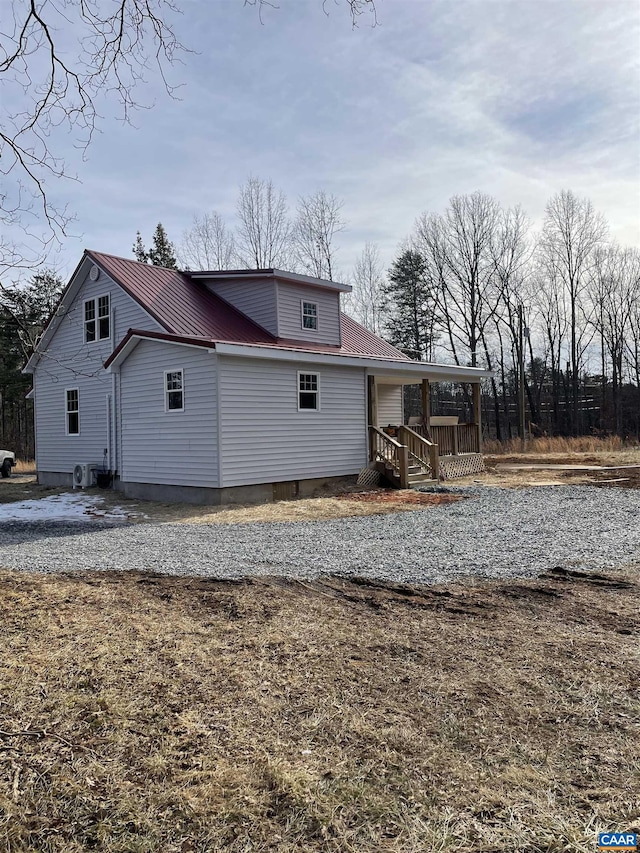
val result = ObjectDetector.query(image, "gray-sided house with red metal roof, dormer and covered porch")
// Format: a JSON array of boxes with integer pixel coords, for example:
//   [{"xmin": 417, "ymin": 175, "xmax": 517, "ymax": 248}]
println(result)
[{"xmin": 20, "ymin": 251, "xmax": 488, "ymax": 504}]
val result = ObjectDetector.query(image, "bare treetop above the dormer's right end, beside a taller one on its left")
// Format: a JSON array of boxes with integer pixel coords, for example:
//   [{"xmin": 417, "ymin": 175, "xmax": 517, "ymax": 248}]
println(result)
[{"xmin": 293, "ymin": 190, "xmax": 345, "ymax": 281}]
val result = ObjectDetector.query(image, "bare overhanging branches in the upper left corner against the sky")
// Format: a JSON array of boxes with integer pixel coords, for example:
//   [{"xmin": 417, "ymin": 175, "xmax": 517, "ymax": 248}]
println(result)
[{"xmin": 0, "ymin": 0, "xmax": 184, "ymax": 269}]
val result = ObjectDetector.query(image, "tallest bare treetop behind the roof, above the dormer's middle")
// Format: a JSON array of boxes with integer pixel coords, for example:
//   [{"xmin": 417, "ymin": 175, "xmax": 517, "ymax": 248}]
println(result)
[{"xmin": 236, "ymin": 175, "xmax": 291, "ymax": 269}]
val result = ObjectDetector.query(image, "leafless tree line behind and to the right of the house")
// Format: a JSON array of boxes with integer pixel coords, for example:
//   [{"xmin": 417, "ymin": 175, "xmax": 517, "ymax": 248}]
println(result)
[{"xmin": 134, "ymin": 183, "xmax": 640, "ymax": 439}]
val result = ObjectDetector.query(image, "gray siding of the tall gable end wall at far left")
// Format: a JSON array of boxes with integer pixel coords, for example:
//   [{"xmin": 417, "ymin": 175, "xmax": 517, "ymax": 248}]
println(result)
[{"xmin": 33, "ymin": 266, "xmax": 159, "ymax": 473}]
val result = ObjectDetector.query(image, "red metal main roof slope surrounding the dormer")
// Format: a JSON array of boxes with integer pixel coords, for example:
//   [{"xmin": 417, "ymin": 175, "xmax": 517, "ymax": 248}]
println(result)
[{"xmin": 87, "ymin": 251, "xmax": 411, "ymax": 361}]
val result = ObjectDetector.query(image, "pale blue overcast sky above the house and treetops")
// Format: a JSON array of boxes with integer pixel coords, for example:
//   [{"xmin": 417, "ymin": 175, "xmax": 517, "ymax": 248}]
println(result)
[{"xmin": 27, "ymin": 0, "xmax": 640, "ymax": 275}]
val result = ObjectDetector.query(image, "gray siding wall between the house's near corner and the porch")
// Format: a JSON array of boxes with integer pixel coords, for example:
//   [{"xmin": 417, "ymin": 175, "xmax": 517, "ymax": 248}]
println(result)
[{"xmin": 218, "ymin": 356, "xmax": 367, "ymax": 486}]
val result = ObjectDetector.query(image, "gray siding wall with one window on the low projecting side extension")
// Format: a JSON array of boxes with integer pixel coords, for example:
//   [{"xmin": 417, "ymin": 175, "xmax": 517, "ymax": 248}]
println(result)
[{"xmin": 120, "ymin": 341, "xmax": 218, "ymax": 487}]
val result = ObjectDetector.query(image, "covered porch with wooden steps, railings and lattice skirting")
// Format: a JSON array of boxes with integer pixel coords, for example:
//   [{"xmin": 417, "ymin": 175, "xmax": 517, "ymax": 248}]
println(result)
[{"xmin": 368, "ymin": 372, "xmax": 484, "ymax": 488}]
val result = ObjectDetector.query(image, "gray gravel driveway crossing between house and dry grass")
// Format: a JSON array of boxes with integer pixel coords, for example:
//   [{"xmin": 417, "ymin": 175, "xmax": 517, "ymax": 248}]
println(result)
[{"xmin": 0, "ymin": 486, "xmax": 640, "ymax": 582}]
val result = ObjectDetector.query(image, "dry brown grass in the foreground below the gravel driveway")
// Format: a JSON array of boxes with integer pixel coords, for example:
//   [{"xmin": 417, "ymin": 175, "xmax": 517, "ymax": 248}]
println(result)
[{"xmin": 0, "ymin": 570, "xmax": 640, "ymax": 853}]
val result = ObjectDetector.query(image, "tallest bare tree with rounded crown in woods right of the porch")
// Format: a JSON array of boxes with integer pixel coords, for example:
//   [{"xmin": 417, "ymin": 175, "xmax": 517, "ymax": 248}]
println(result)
[{"xmin": 540, "ymin": 190, "xmax": 607, "ymax": 434}]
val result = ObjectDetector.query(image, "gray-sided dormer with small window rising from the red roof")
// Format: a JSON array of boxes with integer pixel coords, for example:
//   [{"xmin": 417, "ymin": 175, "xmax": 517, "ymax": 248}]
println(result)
[{"xmin": 189, "ymin": 269, "xmax": 351, "ymax": 347}]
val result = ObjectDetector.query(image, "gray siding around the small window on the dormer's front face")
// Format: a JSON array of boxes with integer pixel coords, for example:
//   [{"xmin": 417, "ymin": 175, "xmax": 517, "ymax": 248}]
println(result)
[{"xmin": 278, "ymin": 281, "xmax": 340, "ymax": 346}]
